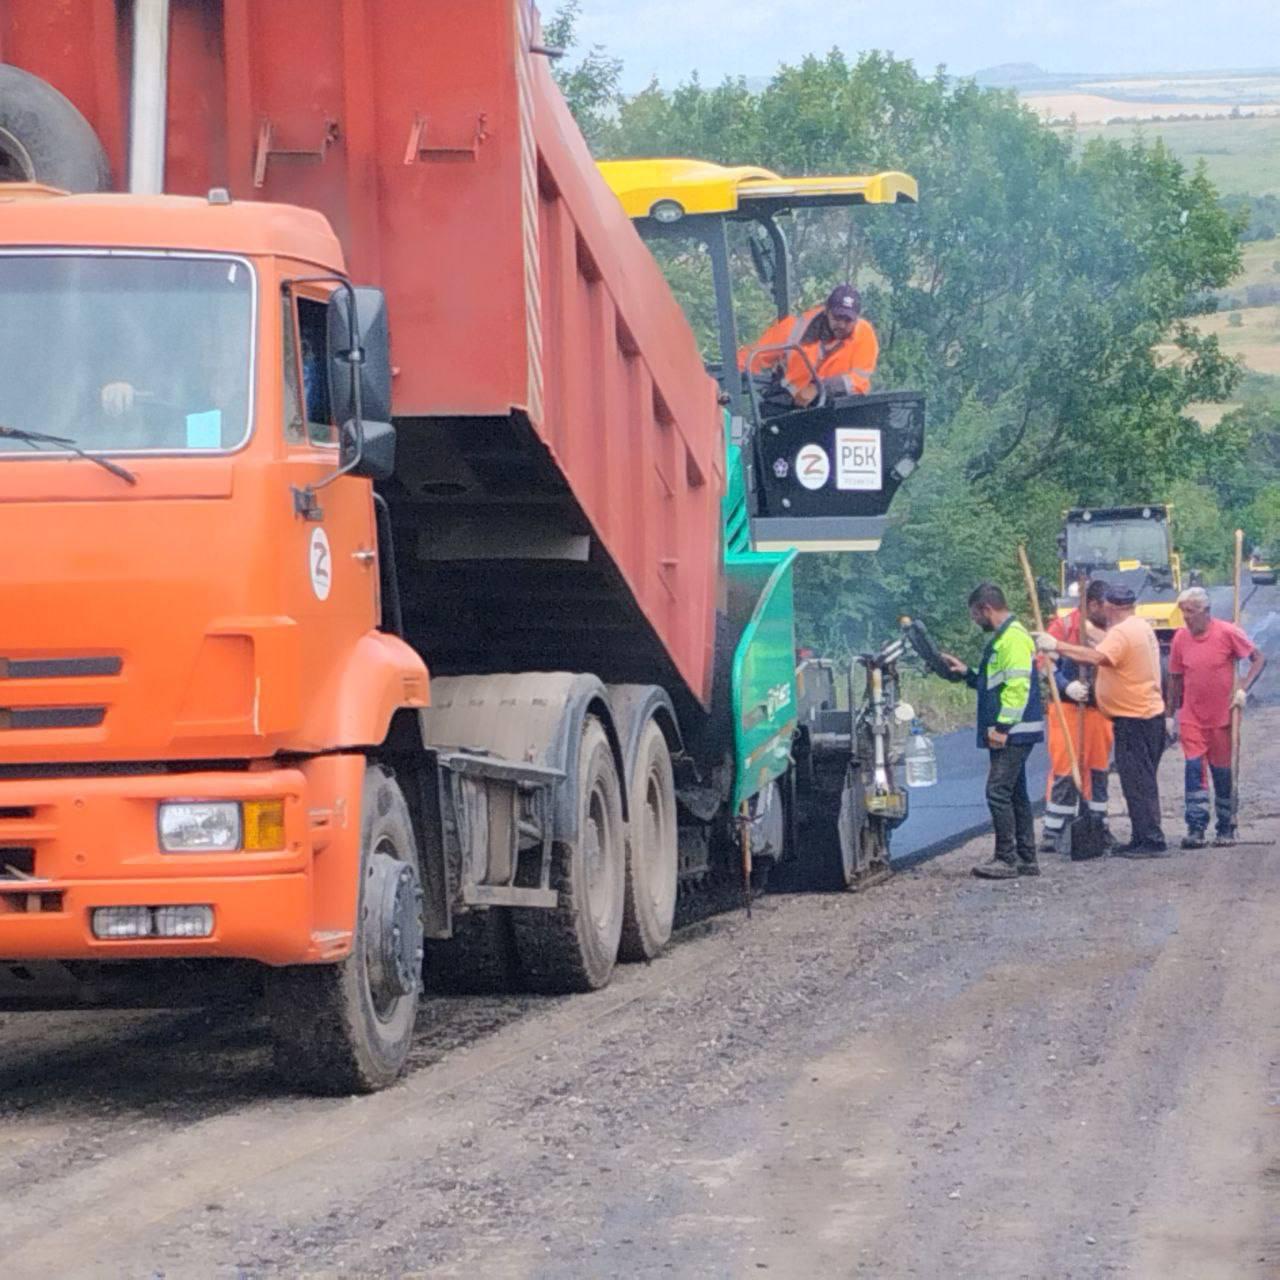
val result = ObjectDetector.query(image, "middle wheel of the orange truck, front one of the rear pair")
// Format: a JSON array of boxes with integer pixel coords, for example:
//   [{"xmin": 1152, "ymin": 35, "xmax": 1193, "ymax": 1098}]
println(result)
[{"xmin": 511, "ymin": 716, "xmax": 626, "ymax": 993}]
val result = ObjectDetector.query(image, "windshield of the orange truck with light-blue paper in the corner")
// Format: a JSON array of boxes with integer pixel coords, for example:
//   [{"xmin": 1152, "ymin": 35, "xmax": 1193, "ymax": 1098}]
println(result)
[{"xmin": 0, "ymin": 253, "xmax": 253, "ymax": 453}]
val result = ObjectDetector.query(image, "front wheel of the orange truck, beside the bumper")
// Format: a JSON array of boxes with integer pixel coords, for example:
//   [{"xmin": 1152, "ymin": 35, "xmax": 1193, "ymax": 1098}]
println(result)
[{"xmin": 266, "ymin": 765, "xmax": 422, "ymax": 1093}]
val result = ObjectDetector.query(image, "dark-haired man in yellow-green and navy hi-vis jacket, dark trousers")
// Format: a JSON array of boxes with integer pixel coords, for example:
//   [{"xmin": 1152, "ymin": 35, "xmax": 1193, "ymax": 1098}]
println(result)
[{"xmin": 942, "ymin": 582, "xmax": 1044, "ymax": 879}]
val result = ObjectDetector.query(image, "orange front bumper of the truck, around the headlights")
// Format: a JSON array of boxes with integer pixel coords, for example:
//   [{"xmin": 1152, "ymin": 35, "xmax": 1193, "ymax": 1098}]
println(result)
[{"xmin": 0, "ymin": 768, "xmax": 351, "ymax": 965}]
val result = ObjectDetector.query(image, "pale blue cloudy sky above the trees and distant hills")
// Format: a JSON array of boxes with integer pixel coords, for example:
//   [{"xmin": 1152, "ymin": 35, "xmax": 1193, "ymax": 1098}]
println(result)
[{"xmin": 570, "ymin": 0, "xmax": 1280, "ymax": 91}]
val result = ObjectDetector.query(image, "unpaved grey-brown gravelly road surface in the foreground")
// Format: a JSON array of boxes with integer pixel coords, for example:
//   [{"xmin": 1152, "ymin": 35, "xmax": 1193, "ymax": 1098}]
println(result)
[{"xmin": 0, "ymin": 727, "xmax": 1280, "ymax": 1280}]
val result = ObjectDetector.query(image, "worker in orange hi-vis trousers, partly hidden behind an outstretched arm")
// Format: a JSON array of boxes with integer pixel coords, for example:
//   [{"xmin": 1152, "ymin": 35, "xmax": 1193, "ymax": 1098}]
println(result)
[{"xmin": 1041, "ymin": 581, "xmax": 1114, "ymax": 852}]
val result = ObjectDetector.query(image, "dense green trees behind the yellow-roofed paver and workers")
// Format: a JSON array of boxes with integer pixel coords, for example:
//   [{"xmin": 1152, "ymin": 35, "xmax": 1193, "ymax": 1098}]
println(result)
[{"xmin": 545, "ymin": 4, "xmax": 1264, "ymax": 652}]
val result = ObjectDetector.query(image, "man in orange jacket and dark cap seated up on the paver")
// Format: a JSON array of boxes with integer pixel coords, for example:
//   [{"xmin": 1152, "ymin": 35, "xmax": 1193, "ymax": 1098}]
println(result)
[{"xmin": 737, "ymin": 284, "xmax": 879, "ymax": 408}]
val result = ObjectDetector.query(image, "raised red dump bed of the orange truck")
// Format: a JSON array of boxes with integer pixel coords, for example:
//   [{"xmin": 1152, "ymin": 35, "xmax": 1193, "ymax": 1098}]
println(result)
[{"xmin": 0, "ymin": 0, "xmax": 723, "ymax": 704}]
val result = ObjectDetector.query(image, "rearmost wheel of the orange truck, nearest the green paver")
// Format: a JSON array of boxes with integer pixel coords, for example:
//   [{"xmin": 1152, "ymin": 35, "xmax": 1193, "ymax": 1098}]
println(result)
[{"xmin": 618, "ymin": 721, "xmax": 680, "ymax": 960}]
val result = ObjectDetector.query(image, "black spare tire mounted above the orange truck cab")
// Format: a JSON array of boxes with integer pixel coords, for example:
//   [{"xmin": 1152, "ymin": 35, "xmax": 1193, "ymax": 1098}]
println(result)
[{"xmin": 0, "ymin": 65, "xmax": 111, "ymax": 192}]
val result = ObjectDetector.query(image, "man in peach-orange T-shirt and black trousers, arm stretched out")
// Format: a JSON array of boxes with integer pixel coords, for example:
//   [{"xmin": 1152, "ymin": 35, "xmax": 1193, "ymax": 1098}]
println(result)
[{"xmin": 1036, "ymin": 584, "xmax": 1169, "ymax": 858}]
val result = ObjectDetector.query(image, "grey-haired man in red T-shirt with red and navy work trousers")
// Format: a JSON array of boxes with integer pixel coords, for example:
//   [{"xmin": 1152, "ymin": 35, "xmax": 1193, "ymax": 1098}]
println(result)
[{"xmin": 1165, "ymin": 586, "xmax": 1267, "ymax": 849}]
